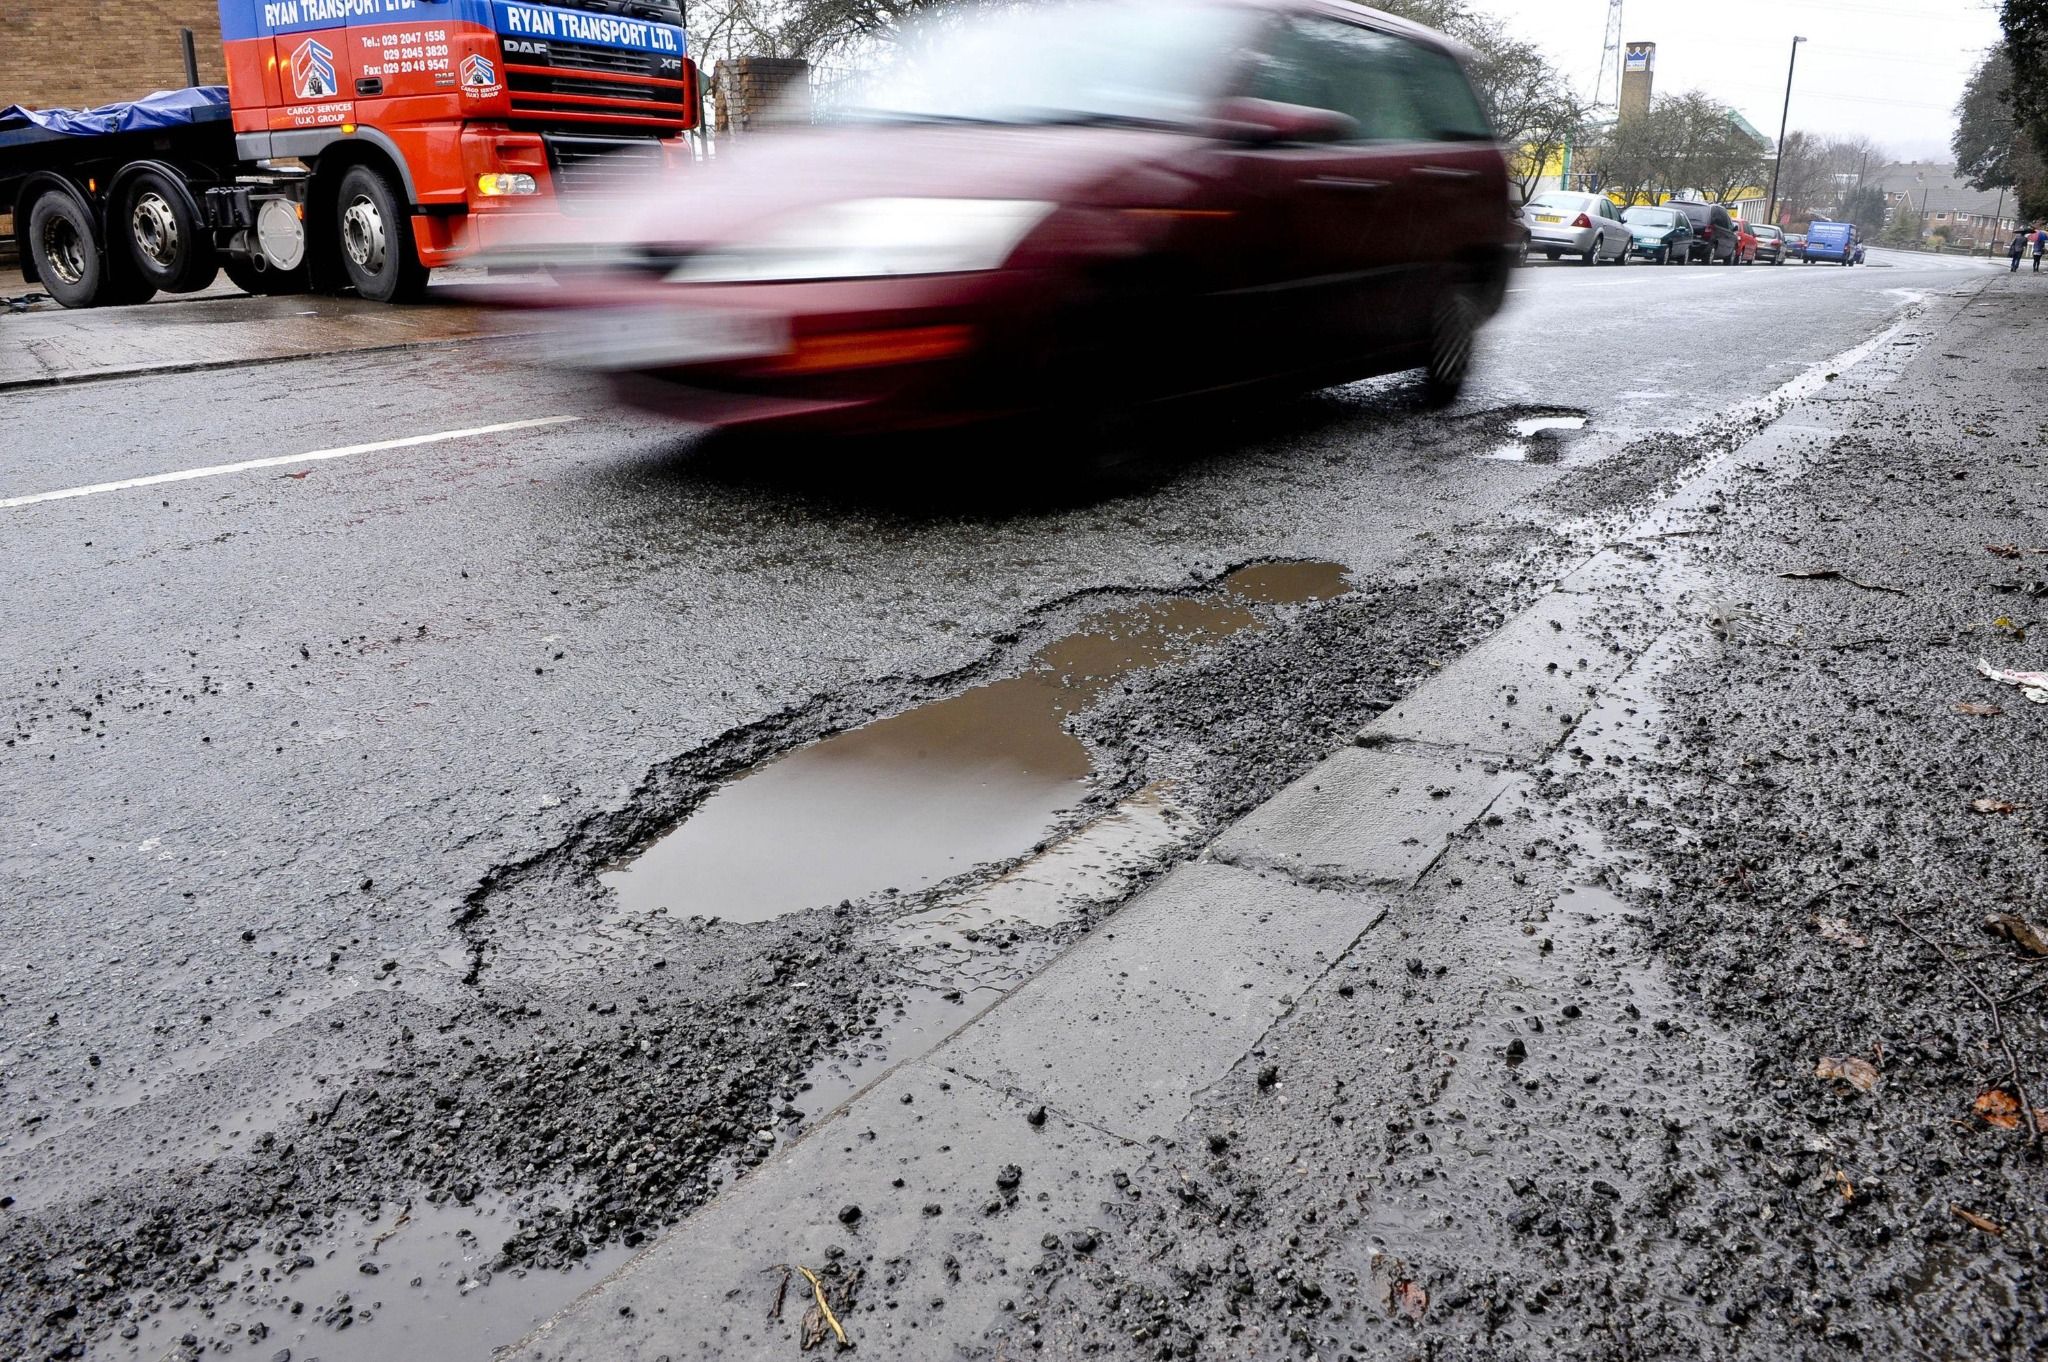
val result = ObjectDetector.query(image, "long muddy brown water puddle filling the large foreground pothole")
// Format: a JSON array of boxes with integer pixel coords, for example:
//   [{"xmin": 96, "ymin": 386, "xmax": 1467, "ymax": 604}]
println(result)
[{"xmin": 600, "ymin": 563, "xmax": 1348, "ymax": 922}]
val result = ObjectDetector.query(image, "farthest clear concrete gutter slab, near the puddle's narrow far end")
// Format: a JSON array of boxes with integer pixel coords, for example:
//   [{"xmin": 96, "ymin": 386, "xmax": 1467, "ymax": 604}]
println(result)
[{"xmin": 1362, "ymin": 592, "xmax": 1651, "ymax": 762}]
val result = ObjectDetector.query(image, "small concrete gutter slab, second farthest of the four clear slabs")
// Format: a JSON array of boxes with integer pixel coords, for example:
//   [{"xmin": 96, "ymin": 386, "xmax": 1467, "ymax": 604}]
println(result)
[{"xmin": 1210, "ymin": 743, "xmax": 1513, "ymax": 889}]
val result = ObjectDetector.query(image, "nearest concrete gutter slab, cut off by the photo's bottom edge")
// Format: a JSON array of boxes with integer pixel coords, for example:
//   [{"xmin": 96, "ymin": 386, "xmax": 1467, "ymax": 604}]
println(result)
[{"xmin": 512, "ymin": 1065, "xmax": 1139, "ymax": 1362}]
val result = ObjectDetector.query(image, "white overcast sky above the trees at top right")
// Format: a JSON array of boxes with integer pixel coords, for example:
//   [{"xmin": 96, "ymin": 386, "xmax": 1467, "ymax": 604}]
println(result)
[{"xmin": 1474, "ymin": 0, "xmax": 1999, "ymax": 162}]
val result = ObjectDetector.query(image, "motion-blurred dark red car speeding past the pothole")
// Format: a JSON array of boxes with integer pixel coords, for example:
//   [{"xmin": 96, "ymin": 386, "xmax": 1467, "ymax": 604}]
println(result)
[{"xmin": 528, "ymin": 0, "xmax": 1511, "ymax": 430}]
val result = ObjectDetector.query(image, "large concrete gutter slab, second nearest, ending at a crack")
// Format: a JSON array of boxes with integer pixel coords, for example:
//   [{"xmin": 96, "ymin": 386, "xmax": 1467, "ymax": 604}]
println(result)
[{"xmin": 930, "ymin": 862, "xmax": 1384, "ymax": 1139}]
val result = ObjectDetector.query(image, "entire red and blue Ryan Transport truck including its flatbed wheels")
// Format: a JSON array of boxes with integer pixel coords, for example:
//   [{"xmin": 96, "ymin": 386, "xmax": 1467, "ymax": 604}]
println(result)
[{"xmin": 0, "ymin": 0, "xmax": 700, "ymax": 307}]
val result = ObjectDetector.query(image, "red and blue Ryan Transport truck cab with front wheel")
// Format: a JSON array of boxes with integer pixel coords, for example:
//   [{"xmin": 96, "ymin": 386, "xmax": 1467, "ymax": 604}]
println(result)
[{"xmin": 219, "ymin": 0, "xmax": 698, "ymax": 297}]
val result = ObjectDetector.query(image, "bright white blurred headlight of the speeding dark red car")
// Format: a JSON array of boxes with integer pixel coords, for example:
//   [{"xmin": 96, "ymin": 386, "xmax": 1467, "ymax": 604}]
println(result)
[{"xmin": 668, "ymin": 199, "xmax": 1053, "ymax": 285}]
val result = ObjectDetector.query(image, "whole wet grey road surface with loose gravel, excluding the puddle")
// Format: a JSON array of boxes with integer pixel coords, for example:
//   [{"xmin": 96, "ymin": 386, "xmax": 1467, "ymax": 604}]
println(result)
[{"xmin": 0, "ymin": 256, "xmax": 2007, "ymax": 1362}]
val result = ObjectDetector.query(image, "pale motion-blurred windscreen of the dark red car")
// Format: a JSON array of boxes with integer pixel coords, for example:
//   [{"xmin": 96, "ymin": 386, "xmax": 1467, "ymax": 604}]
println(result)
[{"xmin": 821, "ymin": 0, "xmax": 1260, "ymax": 125}]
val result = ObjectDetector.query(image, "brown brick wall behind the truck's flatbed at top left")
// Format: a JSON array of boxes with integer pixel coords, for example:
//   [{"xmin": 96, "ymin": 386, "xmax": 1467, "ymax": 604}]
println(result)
[{"xmin": 0, "ymin": 0, "xmax": 227, "ymax": 109}]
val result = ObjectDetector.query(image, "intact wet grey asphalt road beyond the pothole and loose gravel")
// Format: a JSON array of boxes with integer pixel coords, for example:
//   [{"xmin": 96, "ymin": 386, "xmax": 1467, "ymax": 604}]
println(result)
[{"xmin": 0, "ymin": 244, "xmax": 1985, "ymax": 1351}]
